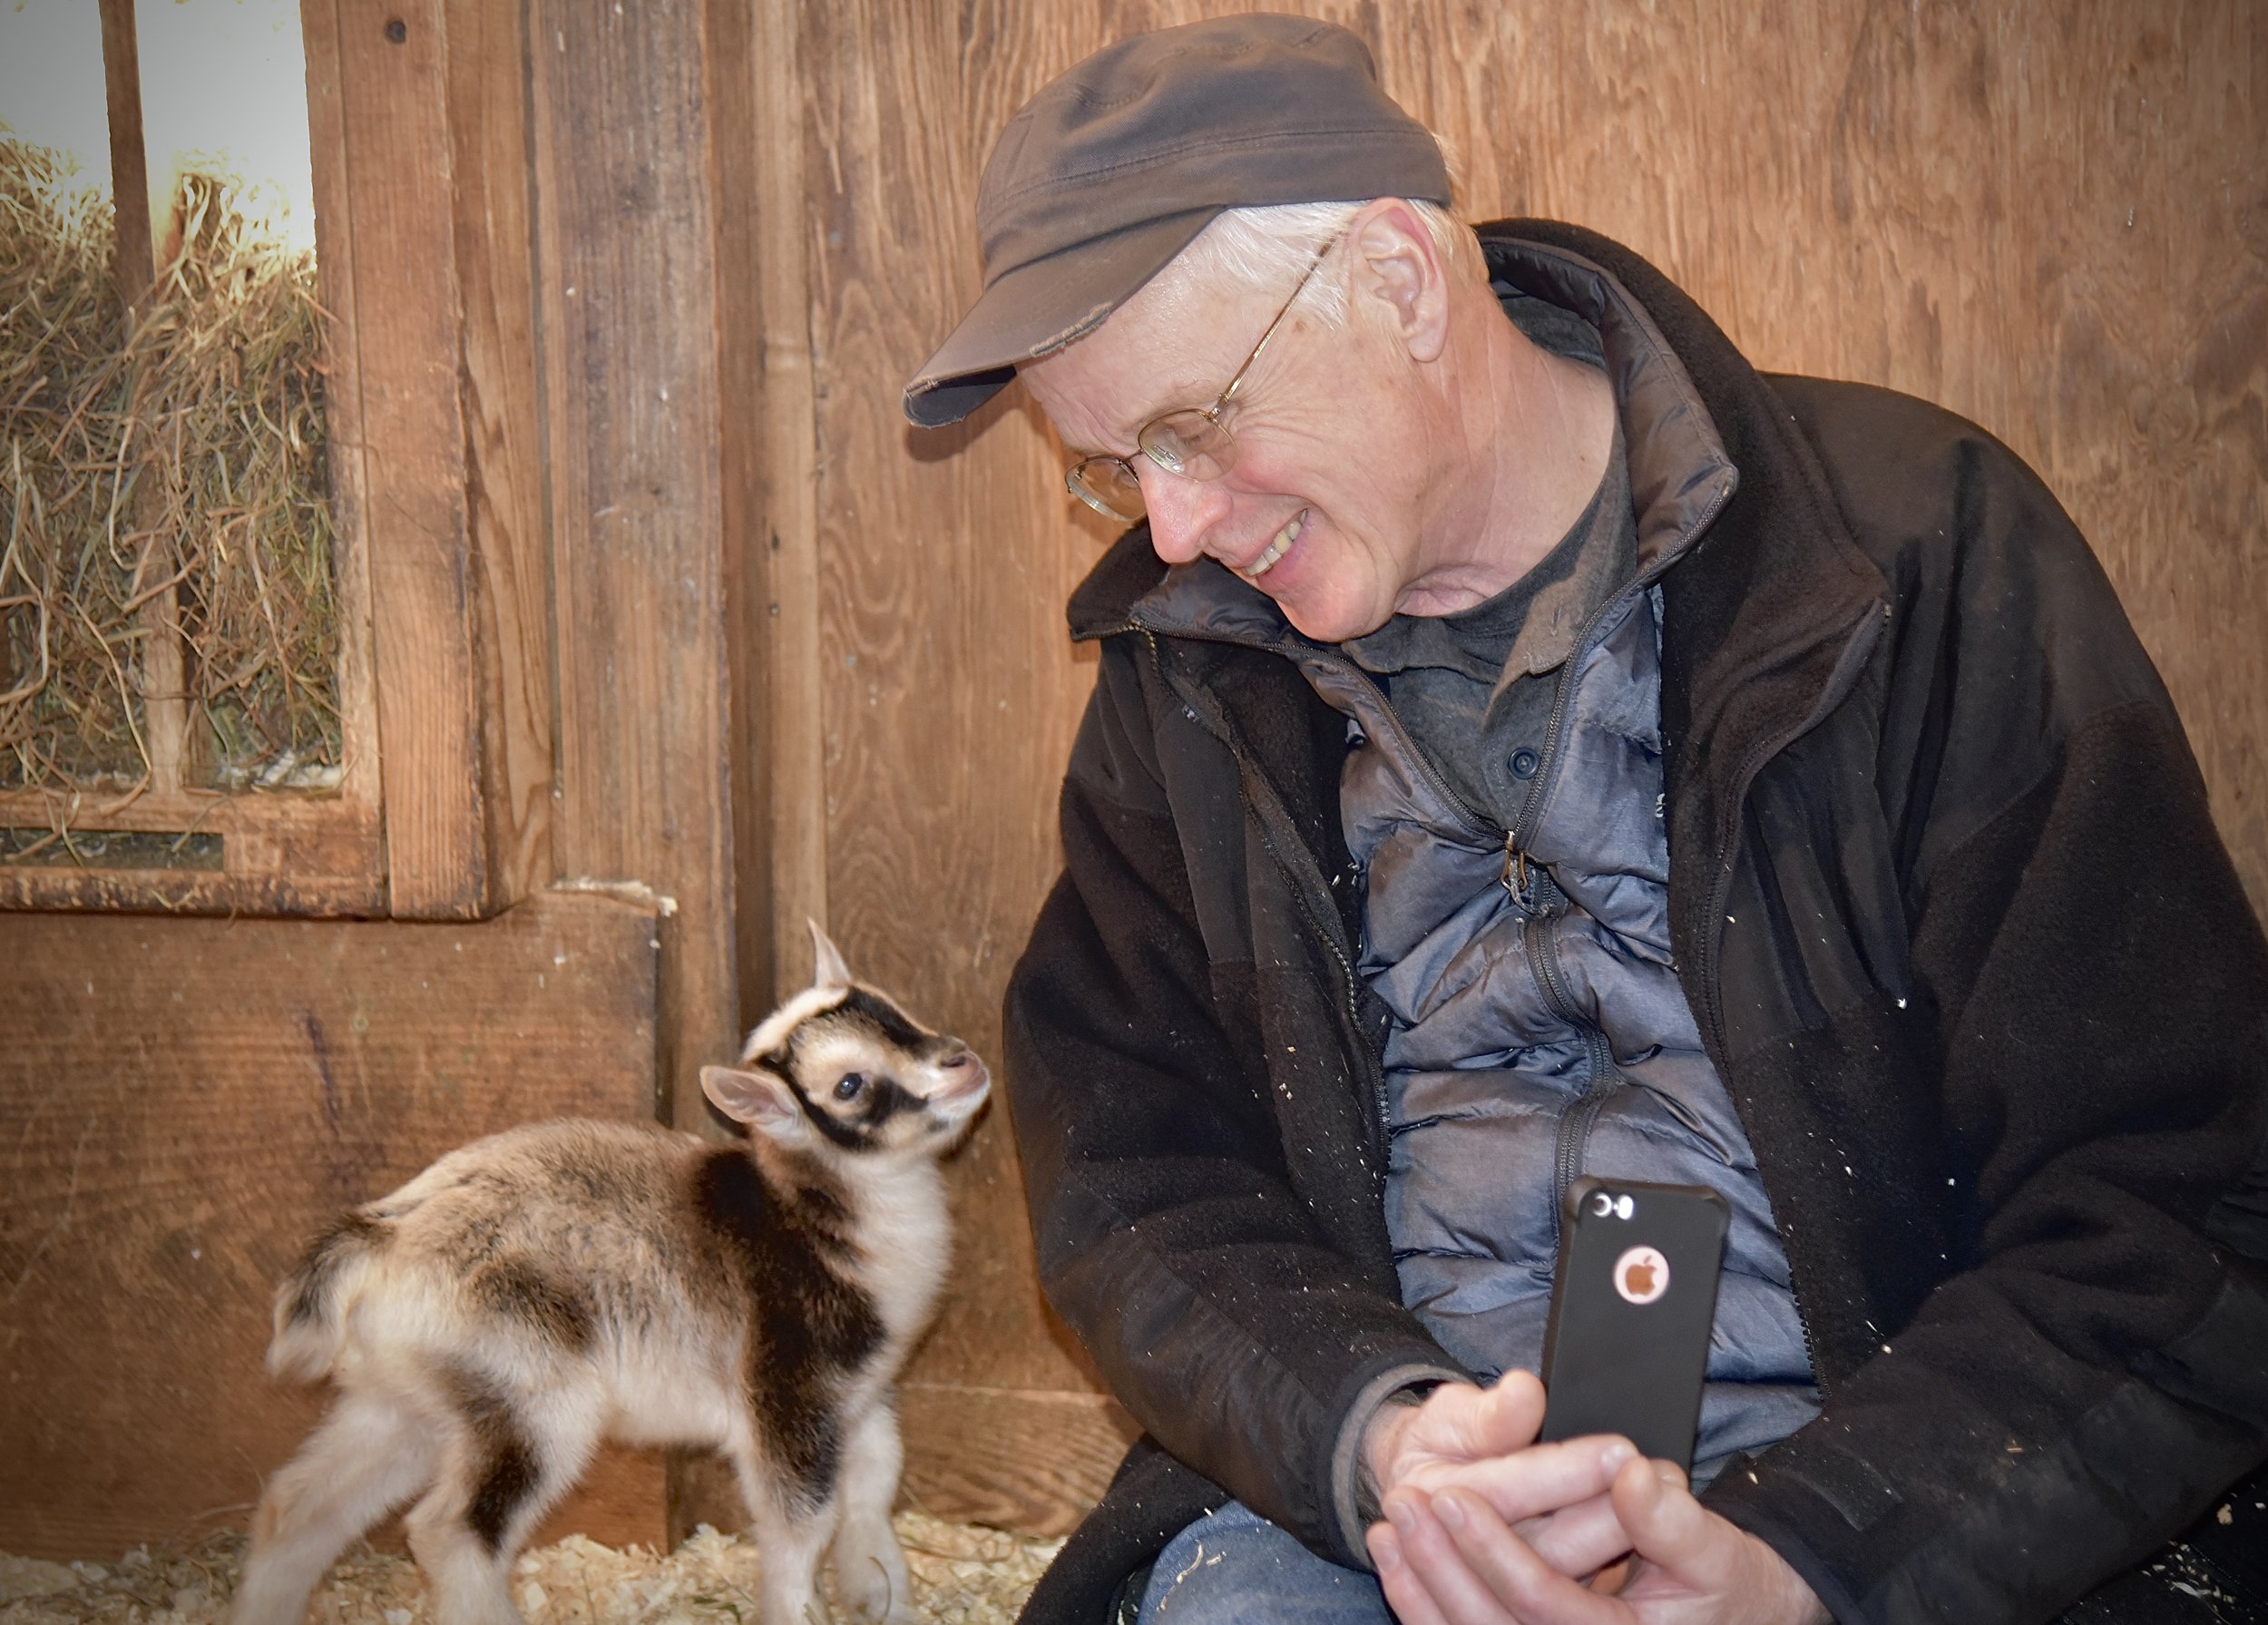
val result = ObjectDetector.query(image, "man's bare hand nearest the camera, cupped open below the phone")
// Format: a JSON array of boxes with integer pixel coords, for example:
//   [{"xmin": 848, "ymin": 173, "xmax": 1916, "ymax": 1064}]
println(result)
[{"xmin": 1370, "ymin": 1453, "xmax": 1828, "ymax": 1625}]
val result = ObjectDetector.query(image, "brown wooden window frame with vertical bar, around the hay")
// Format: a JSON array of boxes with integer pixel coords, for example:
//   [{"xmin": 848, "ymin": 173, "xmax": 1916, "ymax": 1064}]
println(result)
[{"xmin": 0, "ymin": 0, "xmax": 552, "ymax": 919}]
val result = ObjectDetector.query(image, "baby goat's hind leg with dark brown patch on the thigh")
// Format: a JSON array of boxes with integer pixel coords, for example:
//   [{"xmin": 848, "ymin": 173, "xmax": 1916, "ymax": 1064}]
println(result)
[{"xmin": 404, "ymin": 1391, "xmax": 603, "ymax": 1625}]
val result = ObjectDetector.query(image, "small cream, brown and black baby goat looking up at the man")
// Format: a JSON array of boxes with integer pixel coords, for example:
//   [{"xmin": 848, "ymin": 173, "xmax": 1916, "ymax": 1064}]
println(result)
[{"xmin": 231, "ymin": 924, "xmax": 992, "ymax": 1625}]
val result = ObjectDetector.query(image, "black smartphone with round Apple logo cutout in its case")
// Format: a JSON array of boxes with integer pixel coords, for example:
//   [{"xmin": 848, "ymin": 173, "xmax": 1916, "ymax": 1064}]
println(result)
[{"xmin": 1538, "ymin": 1178, "xmax": 1733, "ymax": 1471}]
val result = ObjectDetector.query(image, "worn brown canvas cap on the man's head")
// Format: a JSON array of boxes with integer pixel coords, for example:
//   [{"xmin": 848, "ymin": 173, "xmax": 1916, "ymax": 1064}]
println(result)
[{"xmin": 905, "ymin": 14, "xmax": 1450, "ymax": 429}]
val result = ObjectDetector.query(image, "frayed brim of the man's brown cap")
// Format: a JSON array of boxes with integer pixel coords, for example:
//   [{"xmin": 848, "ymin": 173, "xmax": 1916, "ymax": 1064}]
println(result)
[{"xmin": 905, "ymin": 207, "xmax": 1220, "ymax": 429}]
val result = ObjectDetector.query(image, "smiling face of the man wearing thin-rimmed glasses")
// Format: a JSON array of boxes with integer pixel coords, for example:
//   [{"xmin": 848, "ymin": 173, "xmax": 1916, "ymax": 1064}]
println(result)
[{"xmin": 1021, "ymin": 245, "xmax": 1441, "ymax": 642}]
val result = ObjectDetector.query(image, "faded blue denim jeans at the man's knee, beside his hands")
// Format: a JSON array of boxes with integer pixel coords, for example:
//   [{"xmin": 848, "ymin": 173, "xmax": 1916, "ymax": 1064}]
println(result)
[{"xmin": 1139, "ymin": 1500, "xmax": 1395, "ymax": 1625}]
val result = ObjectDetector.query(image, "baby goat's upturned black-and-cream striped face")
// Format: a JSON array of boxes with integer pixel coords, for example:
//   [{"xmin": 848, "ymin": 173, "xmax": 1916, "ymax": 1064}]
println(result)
[{"xmin": 701, "ymin": 985, "xmax": 992, "ymax": 1153}]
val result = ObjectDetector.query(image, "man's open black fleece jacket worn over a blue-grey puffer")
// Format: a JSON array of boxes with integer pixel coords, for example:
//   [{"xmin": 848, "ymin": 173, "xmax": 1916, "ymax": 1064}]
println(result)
[{"xmin": 1007, "ymin": 220, "xmax": 2268, "ymax": 1625}]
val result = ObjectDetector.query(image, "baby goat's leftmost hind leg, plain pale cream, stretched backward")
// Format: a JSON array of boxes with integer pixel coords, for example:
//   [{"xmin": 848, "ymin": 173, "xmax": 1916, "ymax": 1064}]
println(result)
[{"xmin": 230, "ymin": 1391, "xmax": 435, "ymax": 1625}]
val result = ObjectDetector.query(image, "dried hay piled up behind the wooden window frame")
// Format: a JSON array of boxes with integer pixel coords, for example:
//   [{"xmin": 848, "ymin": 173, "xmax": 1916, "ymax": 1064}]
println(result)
[{"xmin": 0, "ymin": 141, "xmax": 343, "ymax": 789}]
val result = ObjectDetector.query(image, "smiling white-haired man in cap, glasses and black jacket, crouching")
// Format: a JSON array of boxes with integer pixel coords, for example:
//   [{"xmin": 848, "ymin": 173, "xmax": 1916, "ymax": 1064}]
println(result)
[{"xmin": 907, "ymin": 16, "xmax": 2268, "ymax": 1625}]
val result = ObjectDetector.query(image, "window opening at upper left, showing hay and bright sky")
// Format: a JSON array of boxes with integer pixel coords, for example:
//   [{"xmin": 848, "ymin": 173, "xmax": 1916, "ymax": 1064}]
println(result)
[{"xmin": 0, "ymin": 0, "xmax": 331, "ymax": 869}]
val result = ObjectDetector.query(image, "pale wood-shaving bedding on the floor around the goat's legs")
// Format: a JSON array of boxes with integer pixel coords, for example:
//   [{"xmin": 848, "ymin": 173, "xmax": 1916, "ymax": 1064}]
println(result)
[{"xmin": 0, "ymin": 1512, "xmax": 1061, "ymax": 1625}]
